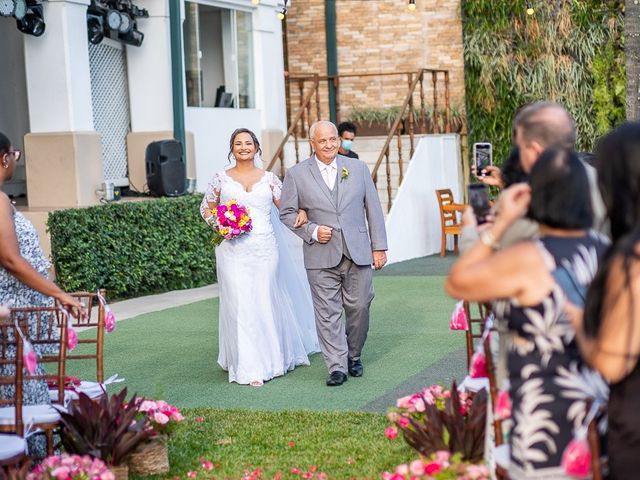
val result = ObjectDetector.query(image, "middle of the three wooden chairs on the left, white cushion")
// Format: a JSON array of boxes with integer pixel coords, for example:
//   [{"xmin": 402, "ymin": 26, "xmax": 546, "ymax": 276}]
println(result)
[{"xmin": 0, "ymin": 307, "xmax": 67, "ymax": 455}]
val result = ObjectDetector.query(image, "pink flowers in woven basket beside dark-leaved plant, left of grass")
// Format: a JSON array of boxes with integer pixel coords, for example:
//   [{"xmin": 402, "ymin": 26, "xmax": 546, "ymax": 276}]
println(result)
[{"xmin": 128, "ymin": 400, "xmax": 184, "ymax": 476}]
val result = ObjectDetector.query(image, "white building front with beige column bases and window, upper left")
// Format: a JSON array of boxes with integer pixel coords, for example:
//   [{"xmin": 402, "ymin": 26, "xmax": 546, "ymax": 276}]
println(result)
[{"xmin": 0, "ymin": 0, "xmax": 286, "ymax": 211}]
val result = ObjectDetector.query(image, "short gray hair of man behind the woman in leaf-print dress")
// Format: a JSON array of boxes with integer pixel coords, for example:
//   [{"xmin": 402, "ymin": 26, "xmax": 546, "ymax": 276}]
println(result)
[{"xmin": 513, "ymin": 101, "xmax": 576, "ymax": 150}]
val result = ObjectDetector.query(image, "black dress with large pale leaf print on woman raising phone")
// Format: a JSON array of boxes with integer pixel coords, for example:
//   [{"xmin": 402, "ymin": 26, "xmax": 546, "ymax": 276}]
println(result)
[{"xmin": 500, "ymin": 233, "xmax": 608, "ymax": 480}]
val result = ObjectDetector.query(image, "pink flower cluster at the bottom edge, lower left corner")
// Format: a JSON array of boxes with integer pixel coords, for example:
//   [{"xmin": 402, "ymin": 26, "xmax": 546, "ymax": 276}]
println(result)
[{"xmin": 27, "ymin": 453, "xmax": 115, "ymax": 480}]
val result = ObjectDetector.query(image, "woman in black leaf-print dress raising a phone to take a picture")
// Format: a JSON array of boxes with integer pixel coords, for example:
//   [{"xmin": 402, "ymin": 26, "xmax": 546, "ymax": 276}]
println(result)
[{"xmin": 446, "ymin": 150, "xmax": 608, "ymax": 480}]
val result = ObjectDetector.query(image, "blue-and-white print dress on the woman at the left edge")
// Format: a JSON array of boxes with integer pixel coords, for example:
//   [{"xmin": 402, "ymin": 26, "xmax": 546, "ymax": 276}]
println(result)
[{"xmin": 0, "ymin": 210, "xmax": 56, "ymax": 458}]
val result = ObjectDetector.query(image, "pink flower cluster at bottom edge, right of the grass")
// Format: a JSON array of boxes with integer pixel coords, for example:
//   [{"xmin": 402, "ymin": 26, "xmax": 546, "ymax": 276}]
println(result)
[{"xmin": 382, "ymin": 450, "xmax": 490, "ymax": 480}]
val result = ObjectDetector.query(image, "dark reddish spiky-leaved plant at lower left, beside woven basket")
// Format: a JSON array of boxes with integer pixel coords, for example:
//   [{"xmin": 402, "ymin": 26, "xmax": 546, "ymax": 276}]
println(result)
[{"xmin": 60, "ymin": 388, "xmax": 153, "ymax": 480}]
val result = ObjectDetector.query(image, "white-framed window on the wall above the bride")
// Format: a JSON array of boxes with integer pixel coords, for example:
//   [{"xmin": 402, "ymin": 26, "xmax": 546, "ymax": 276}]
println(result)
[{"xmin": 184, "ymin": 2, "xmax": 255, "ymax": 108}]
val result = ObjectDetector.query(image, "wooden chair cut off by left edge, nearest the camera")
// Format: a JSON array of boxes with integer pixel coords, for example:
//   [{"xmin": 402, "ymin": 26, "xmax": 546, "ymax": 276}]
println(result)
[{"xmin": 0, "ymin": 320, "xmax": 27, "ymax": 477}]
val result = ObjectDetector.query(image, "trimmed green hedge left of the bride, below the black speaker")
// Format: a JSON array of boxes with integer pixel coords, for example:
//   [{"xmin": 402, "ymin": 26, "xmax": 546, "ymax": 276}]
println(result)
[{"xmin": 47, "ymin": 195, "xmax": 216, "ymax": 299}]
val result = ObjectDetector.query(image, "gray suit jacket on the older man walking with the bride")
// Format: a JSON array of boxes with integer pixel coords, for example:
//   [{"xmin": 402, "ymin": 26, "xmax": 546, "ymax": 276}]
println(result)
[{"xmin": 280, "ymin": 155, "xmax": 387, "ymax": 269}]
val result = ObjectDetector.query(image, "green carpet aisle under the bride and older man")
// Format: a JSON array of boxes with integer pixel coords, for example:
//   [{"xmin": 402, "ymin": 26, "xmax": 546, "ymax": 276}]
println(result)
[{"xmin": 68, "ymin": 257, "xmax": 465, "ymax": 412}]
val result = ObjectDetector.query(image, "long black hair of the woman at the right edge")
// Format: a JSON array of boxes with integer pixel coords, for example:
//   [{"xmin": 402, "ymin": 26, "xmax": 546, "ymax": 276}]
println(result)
[{"xmin": 584, "ymin": 122, "xmax": 640, "ymax": 336}]
